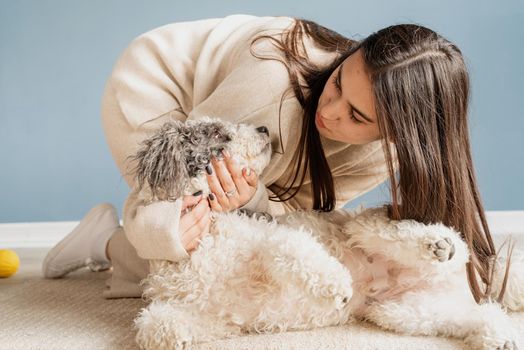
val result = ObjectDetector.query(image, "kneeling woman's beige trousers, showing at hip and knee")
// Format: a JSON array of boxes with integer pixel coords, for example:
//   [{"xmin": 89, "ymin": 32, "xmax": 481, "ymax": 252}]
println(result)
[{"xmin": 101, "ymin": 83, "xmax": 182, "ymax": 299}]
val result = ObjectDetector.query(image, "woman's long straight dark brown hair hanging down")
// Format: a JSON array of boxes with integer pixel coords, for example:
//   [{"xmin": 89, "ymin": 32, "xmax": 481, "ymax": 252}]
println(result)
[{"xmin": 252, "ymin": 19, "xmax": 509, "ymax": 303}]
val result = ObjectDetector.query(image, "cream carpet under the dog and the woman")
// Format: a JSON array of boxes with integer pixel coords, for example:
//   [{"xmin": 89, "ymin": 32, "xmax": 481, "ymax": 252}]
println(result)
[{"xmin": 0, "ymin": 248, "xmax": 524, "ymax": 350}]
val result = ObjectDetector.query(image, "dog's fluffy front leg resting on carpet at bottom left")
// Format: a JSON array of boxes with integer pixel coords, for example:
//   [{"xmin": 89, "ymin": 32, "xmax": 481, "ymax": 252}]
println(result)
[{"xmin": 135, "ymin": 301, "xmax": 242, "ymax": 350}]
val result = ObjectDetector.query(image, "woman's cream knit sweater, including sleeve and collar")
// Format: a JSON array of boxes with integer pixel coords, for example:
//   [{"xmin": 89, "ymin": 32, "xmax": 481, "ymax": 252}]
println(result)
[{"xmin": 109, "ymin": 15, "xmax": 398, "ymax": 262}]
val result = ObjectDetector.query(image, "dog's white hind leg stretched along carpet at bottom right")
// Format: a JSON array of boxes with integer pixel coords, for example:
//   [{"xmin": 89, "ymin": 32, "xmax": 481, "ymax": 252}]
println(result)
[{"xmin": 364, "ymin": 291, "xmax": 520, "ymax": 350}]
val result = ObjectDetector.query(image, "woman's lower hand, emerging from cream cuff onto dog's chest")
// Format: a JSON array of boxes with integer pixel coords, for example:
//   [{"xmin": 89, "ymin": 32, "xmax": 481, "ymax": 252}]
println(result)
[{"xmin": 179, "ymin": 195, "xmax": 211, "ymax": 255}]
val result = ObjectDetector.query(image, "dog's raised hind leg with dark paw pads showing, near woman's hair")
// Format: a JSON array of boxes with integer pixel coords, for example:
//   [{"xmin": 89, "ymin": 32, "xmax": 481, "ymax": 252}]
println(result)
[{"xmin": 343, "ymin": 209, "xmax": 468, "ymax": 274}]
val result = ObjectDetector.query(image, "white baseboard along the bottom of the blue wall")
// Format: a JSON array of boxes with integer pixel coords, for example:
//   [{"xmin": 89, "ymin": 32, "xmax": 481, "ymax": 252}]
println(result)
[{"xmin": 0, "ymin": 210, "xmax": 524, "ymax": 249}]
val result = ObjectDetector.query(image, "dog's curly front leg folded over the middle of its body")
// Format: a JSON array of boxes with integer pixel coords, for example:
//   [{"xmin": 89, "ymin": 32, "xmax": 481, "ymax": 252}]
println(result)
[{"xmin": 260, "ymin": 225, "xmax": 353, "ymax": 309}]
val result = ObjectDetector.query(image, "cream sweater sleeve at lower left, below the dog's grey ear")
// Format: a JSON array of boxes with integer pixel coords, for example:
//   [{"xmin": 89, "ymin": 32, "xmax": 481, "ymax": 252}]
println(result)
[{"xmin": 123, "ymin": 190, "xmax": 189, "ymax": 262}]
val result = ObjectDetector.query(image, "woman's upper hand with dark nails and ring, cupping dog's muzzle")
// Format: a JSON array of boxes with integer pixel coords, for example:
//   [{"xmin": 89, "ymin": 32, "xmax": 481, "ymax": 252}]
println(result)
[{"xmin": 206, "ymin": 150, "xmax": 258, "ymax": 212}]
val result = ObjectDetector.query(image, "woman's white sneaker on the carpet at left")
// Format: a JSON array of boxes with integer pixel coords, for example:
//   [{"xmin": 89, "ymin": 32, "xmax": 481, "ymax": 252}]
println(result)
[{"xmin": 42, "ymin": 203, "xmax": 120, "ymax": 278}]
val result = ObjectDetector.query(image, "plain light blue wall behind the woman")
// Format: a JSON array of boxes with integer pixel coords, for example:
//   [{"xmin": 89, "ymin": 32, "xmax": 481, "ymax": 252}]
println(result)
[{"xmin": 0, "ymin": 0, "xmax": 524, "ymax": 222}]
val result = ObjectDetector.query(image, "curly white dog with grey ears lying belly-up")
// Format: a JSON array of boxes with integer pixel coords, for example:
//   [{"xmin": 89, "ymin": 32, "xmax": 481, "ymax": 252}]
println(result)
[{"xmin": 128, "ymin": 118, "xmax": 524, "ymax": 349}]
